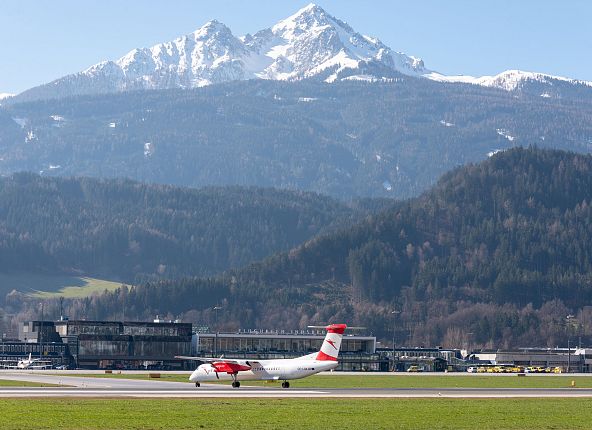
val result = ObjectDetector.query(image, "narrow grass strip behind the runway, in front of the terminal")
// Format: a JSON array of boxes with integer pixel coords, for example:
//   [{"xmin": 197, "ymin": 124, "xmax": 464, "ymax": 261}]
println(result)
[{"xmin": 74, "ymin": 372, "xmax": 592, "ymax": 388}]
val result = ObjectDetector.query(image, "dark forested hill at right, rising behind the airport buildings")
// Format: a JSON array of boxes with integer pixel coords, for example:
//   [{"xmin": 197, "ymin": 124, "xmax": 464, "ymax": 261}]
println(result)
[{"xmin": 48, "ymin": 148, "xmax": 592, "ymax": 347}]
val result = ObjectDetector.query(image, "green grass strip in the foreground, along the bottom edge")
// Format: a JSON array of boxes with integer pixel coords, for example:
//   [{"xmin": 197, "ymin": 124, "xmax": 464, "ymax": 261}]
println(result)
[{"xmin": 0, "ymin": 398, "xmax": 592, "ymax": 430}]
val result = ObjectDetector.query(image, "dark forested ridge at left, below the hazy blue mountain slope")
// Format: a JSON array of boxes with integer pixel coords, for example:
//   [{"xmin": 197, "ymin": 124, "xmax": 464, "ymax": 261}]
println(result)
[{"xmin": 0, "ymin": 173, "xmax": 374, "ymax": 289}]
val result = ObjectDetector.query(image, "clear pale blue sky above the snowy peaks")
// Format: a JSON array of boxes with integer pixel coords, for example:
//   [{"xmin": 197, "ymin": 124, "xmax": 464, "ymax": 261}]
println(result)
[{"xmin": 0, "ymin": 0, "xmax": 592, "ymax": 93}]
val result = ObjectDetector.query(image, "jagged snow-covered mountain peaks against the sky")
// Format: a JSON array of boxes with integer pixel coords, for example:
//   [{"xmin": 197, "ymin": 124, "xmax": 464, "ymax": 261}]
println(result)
[{"xmin": 14, "ymin": 4, "xmax": 592, "ymax": 101}]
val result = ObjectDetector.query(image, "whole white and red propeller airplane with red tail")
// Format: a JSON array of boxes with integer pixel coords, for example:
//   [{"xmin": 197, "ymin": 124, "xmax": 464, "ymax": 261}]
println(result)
[{"xmin": 175, "ymin": 324, "xmax": 347, "ymax": 388}]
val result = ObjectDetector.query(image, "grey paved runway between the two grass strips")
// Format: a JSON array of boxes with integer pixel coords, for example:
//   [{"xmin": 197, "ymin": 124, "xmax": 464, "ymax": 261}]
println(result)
[{"xmin": 0, "ymin": 371, "xmax": 592, "ymax": 399}]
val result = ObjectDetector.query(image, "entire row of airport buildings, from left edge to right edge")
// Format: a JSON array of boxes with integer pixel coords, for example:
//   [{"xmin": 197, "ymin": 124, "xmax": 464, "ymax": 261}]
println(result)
[{"xmin": 5, "ymin": 319, "xmax": 592, "ymax": 372}]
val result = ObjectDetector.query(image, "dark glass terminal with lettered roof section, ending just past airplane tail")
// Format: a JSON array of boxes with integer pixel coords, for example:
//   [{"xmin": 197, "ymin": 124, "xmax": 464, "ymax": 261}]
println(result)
[{"xmin": 8, "ymin": 319, "xmax": 389, "ymax": 371}]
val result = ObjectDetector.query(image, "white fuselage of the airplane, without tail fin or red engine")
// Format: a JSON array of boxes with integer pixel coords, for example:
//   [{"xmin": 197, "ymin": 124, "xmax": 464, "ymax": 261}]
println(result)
[{"xmin": 189, "ymin": 358, "xmax": 338, "ymax": 382}]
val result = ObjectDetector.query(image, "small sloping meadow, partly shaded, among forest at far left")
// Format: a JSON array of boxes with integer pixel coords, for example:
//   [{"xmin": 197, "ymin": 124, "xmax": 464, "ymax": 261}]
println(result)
[{"xmin": 0, "ymin": 273, "xmax": 121, "ymax": 298}]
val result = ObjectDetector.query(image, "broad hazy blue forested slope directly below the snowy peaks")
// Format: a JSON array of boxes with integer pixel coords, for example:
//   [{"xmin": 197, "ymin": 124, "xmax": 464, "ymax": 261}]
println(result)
[{"xmin": 0, "ymin": 77, "xmax": 592, "ymax": 200}]
